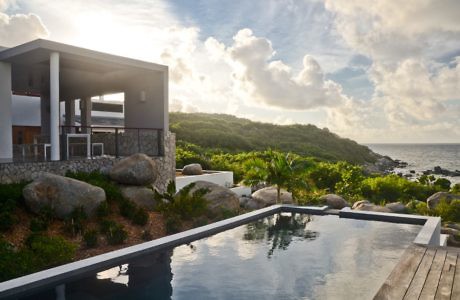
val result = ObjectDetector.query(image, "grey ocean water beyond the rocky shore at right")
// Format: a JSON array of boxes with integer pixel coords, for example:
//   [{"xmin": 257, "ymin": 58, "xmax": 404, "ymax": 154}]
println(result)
[{"xmin": 366, "ymin": 144, "xmax": 460, "ymax": 183}]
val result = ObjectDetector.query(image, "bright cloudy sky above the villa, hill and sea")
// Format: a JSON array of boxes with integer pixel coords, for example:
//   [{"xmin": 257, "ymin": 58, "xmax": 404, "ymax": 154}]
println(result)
[{"xmin": 0, "ymin": 0, "xmax": 460, "ymax": 143}]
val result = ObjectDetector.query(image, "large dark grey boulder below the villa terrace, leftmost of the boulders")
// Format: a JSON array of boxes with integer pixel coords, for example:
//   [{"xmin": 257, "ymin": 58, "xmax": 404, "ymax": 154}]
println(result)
[{"xmin": 23, "ymin": 173, "xmax": 105, "ymax": 219}]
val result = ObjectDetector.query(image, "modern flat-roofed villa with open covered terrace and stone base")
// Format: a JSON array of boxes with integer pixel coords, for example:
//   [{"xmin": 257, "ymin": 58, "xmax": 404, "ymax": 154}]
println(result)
[{"xmin": 0, "ymin": 39, "xmax": 175, "ymax": 189}]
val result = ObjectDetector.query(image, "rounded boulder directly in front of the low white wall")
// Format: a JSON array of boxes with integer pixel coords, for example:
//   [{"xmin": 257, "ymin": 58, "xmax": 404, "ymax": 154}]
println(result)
[{"xmin": 183, "ymin": 180, "xmax": 240, "ymax": 214}]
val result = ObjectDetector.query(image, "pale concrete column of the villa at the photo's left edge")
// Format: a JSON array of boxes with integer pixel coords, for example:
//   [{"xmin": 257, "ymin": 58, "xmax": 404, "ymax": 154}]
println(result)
[{"xmin": 0, "ymin": 62, "xmax": 13, "ymax": 162}]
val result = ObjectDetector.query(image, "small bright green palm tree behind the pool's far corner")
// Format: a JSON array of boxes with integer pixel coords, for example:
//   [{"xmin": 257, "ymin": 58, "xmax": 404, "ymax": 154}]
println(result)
[{"xmin": 243, "ymin": 150, "xmax": 308, "ymax": 203}]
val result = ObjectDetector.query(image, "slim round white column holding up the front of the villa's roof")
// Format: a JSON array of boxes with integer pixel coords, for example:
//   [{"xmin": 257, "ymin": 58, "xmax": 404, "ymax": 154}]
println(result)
[{"xmin": 50, "ymin": 52, "xmax": 61, "ymax": 160}]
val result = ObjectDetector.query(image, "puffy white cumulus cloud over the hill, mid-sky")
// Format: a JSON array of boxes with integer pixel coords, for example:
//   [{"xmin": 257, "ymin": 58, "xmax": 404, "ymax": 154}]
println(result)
[{"xmin": 205, "ymin": 28, "xmax": 345, "ymax": 110}]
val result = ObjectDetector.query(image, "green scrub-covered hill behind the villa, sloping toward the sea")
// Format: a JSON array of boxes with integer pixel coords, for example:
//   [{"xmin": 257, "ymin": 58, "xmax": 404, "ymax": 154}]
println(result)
[{"xmin": 170, "ymin": 113, "xmax": 376, "ymax": 163}]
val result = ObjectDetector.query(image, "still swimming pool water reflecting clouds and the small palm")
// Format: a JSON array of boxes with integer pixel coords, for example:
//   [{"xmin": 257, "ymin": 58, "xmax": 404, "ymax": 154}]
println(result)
[{"xmin": 24, "ymin": 214, "xmax": 421, "ymax": 300}]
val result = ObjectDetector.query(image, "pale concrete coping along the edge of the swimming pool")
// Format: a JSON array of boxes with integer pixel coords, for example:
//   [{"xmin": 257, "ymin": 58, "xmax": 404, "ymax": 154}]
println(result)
[{"xmin": 0, "ymin": 204, "xmax": 442, "ymax": 298}]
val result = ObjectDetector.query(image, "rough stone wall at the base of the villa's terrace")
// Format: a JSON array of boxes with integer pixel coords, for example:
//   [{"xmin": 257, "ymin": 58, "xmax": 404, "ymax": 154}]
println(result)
[{"xmin": 0, "ymin": 132, "xmax": 176, "ymax": 191}]
